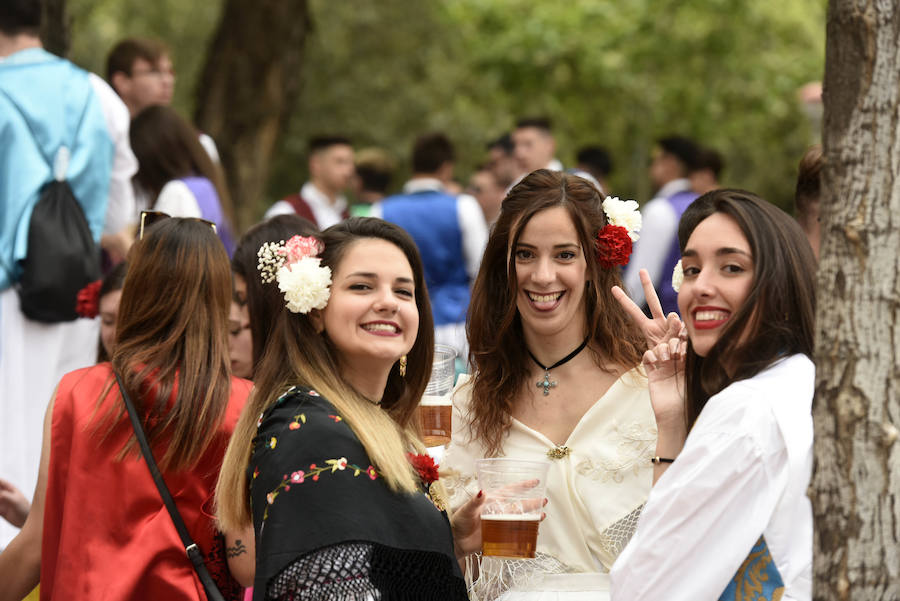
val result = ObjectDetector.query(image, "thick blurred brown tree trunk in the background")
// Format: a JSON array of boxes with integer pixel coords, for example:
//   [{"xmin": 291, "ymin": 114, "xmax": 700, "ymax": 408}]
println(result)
[{"xmin": 195, "ymin": 0, "xmax": 310, "ymax": 230}]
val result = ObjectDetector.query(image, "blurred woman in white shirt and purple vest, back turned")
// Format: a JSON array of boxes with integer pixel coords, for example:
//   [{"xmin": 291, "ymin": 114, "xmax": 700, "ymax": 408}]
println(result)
[{"xmin": 129, "ymin": 105, "xmax": 235, "ymax": 257}]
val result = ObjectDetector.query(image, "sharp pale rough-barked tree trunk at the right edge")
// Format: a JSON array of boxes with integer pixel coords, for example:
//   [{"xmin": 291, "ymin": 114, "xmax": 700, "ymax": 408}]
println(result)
[{"xmin": 810, "ymin": 0, "xmax": 900, "ymax": 601}]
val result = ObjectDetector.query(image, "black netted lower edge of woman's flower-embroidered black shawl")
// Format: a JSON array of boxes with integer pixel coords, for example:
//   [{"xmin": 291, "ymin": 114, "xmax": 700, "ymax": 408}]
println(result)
[{"xmin": 265, "ymin": 542, "xmax": 468, "ymax": 601}]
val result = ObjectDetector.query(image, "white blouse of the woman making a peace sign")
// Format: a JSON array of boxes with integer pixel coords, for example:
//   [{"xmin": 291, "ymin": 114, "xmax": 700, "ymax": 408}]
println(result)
[{"xmin": 611, "ymin": 355, "xmax": 815, "ymax": 601}]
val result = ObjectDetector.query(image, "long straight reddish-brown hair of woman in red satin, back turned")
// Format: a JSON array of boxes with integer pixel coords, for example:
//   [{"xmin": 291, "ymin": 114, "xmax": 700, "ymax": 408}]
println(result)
[{"xmin": 104, "ymin": 218, "xmax": 231, "ymax": 469}]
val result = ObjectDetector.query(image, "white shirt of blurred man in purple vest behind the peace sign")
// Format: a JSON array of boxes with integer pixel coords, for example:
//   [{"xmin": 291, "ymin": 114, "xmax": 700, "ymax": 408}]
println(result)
[{"xmin": 623, "ymin": 178, "xmax": 691, "ymax": 306}]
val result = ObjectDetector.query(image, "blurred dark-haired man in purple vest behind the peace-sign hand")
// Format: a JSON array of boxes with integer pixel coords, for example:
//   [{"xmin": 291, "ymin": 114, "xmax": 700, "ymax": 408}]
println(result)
[{"xmin": 624, "ymin": 136, "xmax": 699, "ymax": 314}]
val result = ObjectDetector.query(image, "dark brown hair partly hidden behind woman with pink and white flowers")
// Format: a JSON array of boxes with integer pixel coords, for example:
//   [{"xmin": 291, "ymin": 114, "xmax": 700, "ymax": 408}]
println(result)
[{"xmin": 231, "ymin": 215, "xmax": 319, "ymax": 372}]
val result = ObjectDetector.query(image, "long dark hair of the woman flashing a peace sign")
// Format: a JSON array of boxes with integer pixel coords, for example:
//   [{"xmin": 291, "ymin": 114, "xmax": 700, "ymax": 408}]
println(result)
[{"xmin": 678, "ymin": 189, "xmax": 816, "ymax": 427}]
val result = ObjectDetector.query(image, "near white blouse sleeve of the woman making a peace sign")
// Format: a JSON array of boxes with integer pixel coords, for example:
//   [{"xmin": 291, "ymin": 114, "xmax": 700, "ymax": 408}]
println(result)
[{"xmin": 611, "ymin": 398, "xmax": 789, "ymax": 601}]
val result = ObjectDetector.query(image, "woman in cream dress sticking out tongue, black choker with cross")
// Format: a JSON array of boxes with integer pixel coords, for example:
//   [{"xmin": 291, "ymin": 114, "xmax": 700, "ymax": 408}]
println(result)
[{"xmin": 442, "ymin": 170, "xmax": 677, "ymax": 600}]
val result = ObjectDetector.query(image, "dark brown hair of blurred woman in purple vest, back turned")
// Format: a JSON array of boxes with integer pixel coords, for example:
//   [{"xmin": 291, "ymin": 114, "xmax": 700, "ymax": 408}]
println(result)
[{"xmin": 129, "ymin": 105, "xmax": 234, "ymax": 223}]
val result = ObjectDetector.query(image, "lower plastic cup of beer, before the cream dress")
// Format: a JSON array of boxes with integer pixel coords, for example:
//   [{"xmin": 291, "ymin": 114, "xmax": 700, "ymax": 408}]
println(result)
[{"xmin": 475, "ymin": 458, "xmax": 550, "ymax": 558}]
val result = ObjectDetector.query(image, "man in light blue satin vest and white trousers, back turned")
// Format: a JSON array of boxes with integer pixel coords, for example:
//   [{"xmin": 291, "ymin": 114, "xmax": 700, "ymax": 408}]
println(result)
[{"xmin": 0, "ymin": 0, "xmax": 137, "ymax": 549}]
